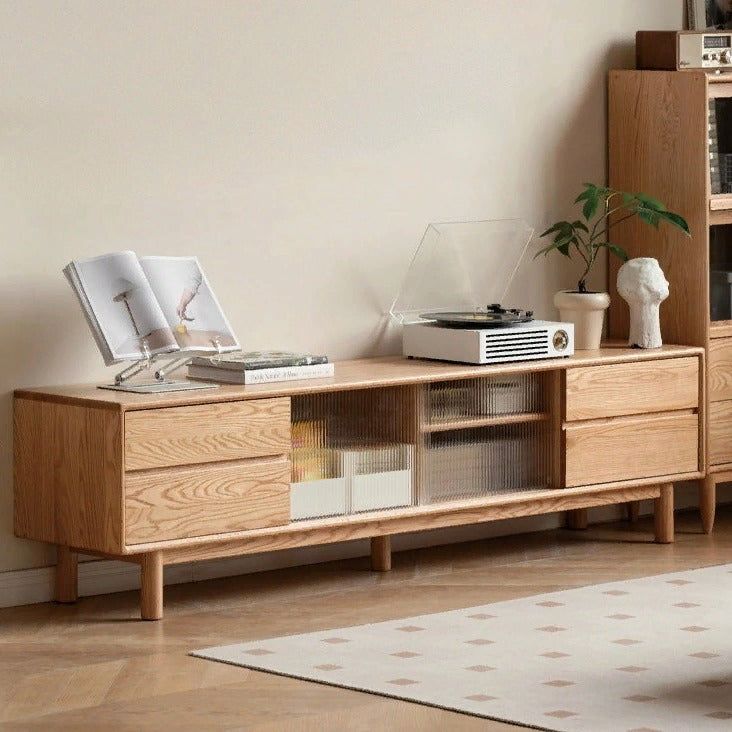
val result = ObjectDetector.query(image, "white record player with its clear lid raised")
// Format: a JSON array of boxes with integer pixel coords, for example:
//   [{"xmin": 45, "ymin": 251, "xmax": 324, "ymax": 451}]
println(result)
[{"xmin": 390, "ymin": 219, "xmax": 574, "ymax": 364}]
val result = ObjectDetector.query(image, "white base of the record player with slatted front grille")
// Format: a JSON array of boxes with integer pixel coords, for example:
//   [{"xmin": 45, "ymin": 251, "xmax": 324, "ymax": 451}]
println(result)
[{"xmin": 402, "ymin": 320, "xmax": 574, "ymax": 364}]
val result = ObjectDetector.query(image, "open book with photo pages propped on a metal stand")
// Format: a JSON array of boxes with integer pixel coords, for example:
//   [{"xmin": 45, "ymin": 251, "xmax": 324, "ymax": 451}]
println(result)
[{"xmin": 64, "ymin": 252, "xmax": 239, "ymax": 366}]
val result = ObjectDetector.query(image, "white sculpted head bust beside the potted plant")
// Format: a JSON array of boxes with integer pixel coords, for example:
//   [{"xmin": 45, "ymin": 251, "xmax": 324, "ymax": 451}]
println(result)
[{"xmin": 618, "ymin": 257, "xmax": 668, "ymax": 348}]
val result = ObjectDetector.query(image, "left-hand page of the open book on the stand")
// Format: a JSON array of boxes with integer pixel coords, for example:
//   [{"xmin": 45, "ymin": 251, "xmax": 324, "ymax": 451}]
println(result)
[{"xmin": 70, "ymin": 252, "xmax": 178, "ymax": 365}]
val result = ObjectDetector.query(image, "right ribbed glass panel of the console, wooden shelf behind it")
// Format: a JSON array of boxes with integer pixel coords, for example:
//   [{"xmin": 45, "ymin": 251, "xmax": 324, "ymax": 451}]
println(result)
[{"xmin": 419, "ymin": 374, "xmax": 551, "ymax": 504}]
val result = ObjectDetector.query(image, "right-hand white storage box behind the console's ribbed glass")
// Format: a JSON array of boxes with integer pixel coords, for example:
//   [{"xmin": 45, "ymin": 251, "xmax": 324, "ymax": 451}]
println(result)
[{"xmin": 340, "ymin": 444, "xmax": 413, "ymax": 513}]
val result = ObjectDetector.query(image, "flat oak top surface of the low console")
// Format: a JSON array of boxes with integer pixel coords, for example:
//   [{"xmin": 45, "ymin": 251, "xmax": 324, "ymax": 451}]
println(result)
[{"xmin": 15, "ymin": 344, "xmax": 703, "ymax": 411}]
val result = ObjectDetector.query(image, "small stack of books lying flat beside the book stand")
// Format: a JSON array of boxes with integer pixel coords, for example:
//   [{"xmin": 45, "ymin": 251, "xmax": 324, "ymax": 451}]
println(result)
[{"xmin": 188, "ymin": 351, "xmax": 335, "ymax": 384}]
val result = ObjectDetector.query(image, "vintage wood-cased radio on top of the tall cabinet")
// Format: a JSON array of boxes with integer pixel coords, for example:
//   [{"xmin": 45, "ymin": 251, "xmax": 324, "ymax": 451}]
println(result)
[{"xmin": 635, "ymin": 30, "xmax": 732, "ymax": 72}]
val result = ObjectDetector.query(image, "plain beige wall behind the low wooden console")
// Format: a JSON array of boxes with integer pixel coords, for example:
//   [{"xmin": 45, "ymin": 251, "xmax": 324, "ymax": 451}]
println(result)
[{"xmin": 0, "ymin": 0, "xmax": 683, "ymax": 571}]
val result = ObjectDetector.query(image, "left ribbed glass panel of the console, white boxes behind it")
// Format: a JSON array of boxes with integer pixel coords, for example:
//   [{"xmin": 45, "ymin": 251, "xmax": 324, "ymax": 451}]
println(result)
[{"xmin": 290, "ymin": 387, "xmax": 417, "ymax": 519}]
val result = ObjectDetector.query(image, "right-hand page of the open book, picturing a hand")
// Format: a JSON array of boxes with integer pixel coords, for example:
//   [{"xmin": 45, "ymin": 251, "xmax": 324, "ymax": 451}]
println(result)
[{"xmin": 140, "ymin": 257, "xmax": 239, "ymax": 353}]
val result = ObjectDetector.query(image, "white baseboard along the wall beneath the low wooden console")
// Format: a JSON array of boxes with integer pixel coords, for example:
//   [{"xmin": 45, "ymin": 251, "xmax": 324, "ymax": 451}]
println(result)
[{"xmin": 0, "ymin": 485, "xmax": 697, "ymax": 607}]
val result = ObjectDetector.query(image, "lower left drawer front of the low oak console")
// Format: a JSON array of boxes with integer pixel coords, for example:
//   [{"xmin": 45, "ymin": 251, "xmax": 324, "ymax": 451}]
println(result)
[{"xmin": 125, "ymin": 457, "xmax": 291, "ymax": 545}]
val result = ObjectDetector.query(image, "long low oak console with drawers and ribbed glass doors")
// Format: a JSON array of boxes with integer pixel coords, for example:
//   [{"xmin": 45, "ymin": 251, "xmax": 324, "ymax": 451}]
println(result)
[{"xmin": 14, "ymin": 346, "xmax": 705, "ymax": 620}]
